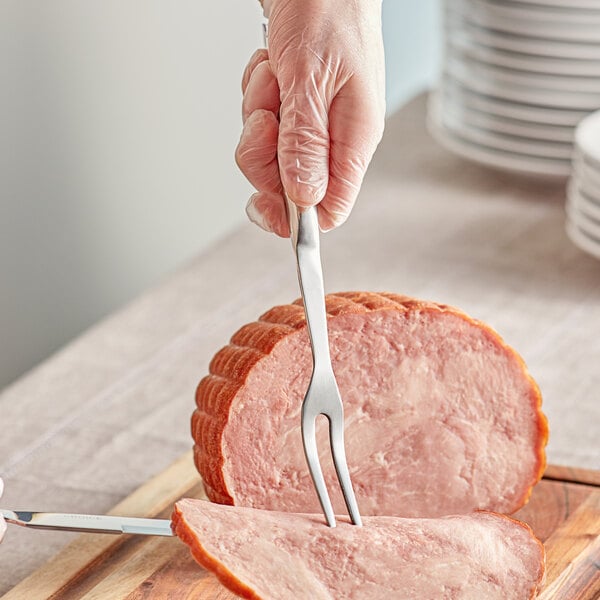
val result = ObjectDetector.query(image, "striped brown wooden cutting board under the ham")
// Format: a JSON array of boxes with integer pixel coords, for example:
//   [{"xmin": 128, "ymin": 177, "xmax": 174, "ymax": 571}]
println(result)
[{"xmin": 3, "ymin": 453, "xmax": 600, "ymax": 600}]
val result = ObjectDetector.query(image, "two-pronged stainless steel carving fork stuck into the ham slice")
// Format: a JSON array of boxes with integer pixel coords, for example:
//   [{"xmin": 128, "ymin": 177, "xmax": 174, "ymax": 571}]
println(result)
[{"xmin": 287, "ymin": 199, "xmax": 362, "ymax": 527}]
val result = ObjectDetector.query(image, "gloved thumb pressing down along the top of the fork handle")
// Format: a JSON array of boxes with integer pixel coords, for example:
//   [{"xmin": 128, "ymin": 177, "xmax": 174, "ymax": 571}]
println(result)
[{"xmin": 278, "ymin": 53, "xmax": 330, "ymax": 207}]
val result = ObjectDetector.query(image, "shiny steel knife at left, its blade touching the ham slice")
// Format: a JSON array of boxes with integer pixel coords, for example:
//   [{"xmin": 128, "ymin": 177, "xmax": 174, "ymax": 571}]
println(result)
[{"xmin": 0, "ymin": 508, "xmax": 173, "ymax": 536}]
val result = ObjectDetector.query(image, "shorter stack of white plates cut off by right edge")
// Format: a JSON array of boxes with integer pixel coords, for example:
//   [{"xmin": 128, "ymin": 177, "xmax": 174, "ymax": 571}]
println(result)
[{"xmin": 567, "ymin": 111, "xmax": 600, "ymax": 258}]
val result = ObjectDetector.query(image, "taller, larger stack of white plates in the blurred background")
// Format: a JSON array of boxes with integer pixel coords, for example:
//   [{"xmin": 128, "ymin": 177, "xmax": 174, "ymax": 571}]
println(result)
[{"xmin": 429, "ymin": 0, "xmax": 600, "ymax": 178}]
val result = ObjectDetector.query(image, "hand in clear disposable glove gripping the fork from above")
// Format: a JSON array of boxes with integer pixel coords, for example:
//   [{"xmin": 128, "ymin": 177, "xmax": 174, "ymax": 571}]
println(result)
[{"xmin": 236, "ymin": 0, "xmax": 385, "ymax": 237}]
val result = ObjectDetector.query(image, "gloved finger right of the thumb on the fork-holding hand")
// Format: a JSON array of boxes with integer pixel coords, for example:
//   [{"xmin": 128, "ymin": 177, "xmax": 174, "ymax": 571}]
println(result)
[{"xmin": 318, "ymin": 81, "xmax": 385, "ymax": 231}]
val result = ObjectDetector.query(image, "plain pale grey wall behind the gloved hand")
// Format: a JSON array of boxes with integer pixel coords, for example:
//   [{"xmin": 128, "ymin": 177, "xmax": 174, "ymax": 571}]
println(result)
[{"xmin": 0, "ymin": 0, "xmax": 440, "ymax": 387}]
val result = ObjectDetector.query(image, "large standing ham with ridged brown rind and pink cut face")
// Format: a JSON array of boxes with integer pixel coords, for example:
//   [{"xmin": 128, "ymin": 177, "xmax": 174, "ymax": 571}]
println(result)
[{"xmin": 192, "ymin": 292, "xmax": 548, "ymax": 517}]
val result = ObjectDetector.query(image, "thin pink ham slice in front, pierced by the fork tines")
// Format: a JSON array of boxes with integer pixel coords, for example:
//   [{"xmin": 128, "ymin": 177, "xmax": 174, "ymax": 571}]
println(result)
[{"xmin": 173, "ymin": 500, "xmax": 544, "ymax": 600}]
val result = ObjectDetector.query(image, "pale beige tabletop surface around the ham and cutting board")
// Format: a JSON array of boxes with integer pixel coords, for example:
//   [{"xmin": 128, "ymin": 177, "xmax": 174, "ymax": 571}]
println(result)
[{"xmin": 0, "ymin": 97, "xmax": 600, "ymax": 593}]
